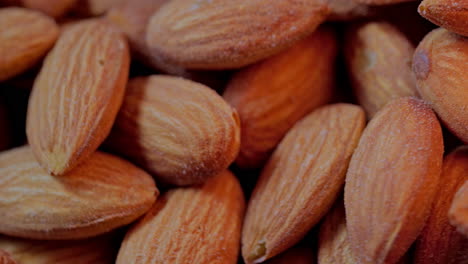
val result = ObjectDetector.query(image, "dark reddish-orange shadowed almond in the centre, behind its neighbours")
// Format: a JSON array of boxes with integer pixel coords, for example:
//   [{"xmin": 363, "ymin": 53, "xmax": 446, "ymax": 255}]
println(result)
[{"xmin": 223, "ymin": 28, "xmax": 337, "ymax": 168}]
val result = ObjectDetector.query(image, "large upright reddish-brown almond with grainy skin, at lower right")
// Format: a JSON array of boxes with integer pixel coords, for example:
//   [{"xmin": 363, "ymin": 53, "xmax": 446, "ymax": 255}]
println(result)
[{"xmin": 345, "ymin": 97, "xmax": 444, "ymax": 264}]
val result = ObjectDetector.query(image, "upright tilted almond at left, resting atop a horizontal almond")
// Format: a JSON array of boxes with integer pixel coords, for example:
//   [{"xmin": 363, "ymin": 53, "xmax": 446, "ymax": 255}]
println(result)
[{"xmin": 26, "ymin": 20, "xmax": 130, "ymax": 175}]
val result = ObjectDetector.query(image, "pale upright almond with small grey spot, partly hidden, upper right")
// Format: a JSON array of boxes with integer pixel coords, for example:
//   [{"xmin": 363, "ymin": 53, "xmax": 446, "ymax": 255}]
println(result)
[{"xmin": 345, "ymin": 22, "xmax": 417, "ymax": 118}]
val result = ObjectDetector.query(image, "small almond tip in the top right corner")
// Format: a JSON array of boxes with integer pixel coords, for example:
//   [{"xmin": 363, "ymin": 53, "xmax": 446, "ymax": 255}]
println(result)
[{"xmin": 418, "ymin": 0, "xmax": 468, "ymax": 37}]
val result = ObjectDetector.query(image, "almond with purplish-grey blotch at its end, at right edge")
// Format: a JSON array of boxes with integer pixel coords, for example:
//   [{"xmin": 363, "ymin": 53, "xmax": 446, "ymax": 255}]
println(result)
[{"xmin": 413, "ymin": 28, "xmax": 468, "ymax": 143}]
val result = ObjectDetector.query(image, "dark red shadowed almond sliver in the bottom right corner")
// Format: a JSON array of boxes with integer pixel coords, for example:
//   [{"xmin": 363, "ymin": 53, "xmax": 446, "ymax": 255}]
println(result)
[{"xmin": 413, "ymin": 147, "xmax": 468, "ymax": 264}]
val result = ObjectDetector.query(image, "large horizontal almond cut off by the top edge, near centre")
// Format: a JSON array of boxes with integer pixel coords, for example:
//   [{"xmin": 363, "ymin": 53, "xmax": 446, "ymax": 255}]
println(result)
[{"xmin": 146, "ymin": 0, "xmax": 327, "ymax": 69}]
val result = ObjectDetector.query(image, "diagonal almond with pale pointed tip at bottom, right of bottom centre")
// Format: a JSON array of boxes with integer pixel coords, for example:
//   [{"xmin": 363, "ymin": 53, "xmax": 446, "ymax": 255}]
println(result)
[{"xmin": 242, "ymin": 104, "xmax": 365, "ymax": 264}]
